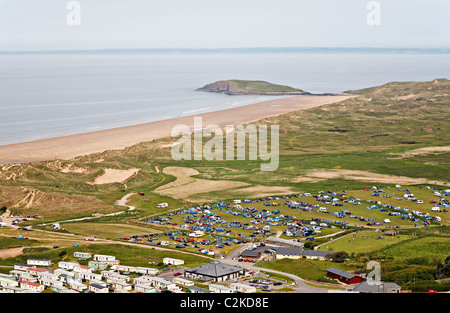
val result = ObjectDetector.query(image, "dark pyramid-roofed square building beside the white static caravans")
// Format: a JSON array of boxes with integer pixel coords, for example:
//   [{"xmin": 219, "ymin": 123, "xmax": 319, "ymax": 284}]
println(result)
[{"xmin": 184, "ymin": 261, "xmax": 244, "ymax": 282}]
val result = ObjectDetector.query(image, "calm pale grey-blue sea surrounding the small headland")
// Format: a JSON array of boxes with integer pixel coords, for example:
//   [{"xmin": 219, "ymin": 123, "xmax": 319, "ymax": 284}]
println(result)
[{"xmin": 0, "ymin": 51, "xmax": 450, "ymax": 145}]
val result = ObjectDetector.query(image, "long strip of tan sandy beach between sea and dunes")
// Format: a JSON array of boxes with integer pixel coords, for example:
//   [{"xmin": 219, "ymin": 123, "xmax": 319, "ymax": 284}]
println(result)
[{"xmin": 0, "ymin": 95, "xmax": 353, "ymax": 163}]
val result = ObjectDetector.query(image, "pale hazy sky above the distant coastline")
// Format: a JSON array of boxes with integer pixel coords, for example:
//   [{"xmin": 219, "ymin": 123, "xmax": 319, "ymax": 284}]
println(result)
[{"xmin": 0, "ymin": 0, "xmax": 450, "ymax": 51}]
